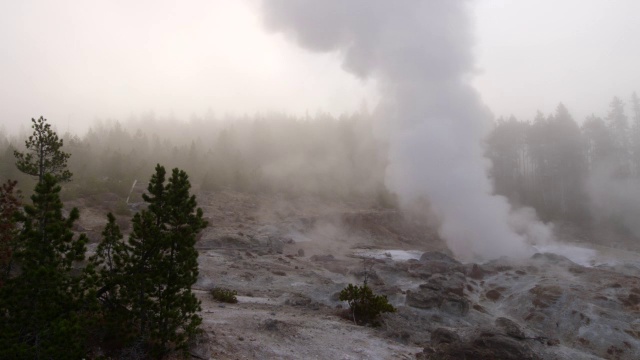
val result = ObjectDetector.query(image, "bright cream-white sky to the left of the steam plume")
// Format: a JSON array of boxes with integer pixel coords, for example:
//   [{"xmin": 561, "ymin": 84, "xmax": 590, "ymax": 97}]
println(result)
[{"xmin": 0, "ymin": 0, "xmax": 375, "ymax": 132}]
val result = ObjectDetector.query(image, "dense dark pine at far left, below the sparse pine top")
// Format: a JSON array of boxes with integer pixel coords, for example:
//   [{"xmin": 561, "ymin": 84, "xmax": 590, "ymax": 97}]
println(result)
[{"xmin": 0, "ymin": 174, "xmax": 87, "ymax": 359}]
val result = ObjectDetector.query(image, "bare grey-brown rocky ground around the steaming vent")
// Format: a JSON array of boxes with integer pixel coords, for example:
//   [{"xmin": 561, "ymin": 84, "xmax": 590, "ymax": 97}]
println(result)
[{"xmin": 70, "ymin": 192, "xmax": 640, "ymax": 359}]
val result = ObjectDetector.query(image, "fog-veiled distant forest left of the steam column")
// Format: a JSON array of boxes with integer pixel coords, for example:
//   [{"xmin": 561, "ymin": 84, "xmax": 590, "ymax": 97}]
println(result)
[{"xmin": 0, "ymin": 111, "xmax": 388, "ymax": 199}]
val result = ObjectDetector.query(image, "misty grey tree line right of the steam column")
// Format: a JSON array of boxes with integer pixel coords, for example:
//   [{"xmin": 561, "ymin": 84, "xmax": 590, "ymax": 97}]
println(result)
[{"xmin": 486, "ymin": 93, "xmax": 640, "ymax": 229}]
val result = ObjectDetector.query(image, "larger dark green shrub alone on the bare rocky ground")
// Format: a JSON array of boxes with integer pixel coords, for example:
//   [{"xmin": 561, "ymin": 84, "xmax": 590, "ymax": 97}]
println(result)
[{"xmin": 339, "ymin": 284, "xmax": 396, "ymax": 325}]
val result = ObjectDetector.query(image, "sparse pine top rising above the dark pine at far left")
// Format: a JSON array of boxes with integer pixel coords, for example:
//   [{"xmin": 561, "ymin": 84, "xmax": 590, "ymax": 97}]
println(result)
[{"xmin": 14, "ymin": 116, "xmax": 71, "ymax": 182}]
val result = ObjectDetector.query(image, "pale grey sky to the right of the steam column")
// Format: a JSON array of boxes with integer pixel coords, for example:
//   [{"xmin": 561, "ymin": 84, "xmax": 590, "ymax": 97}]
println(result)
[{"xmin": 475, "ymin": 0, "xmax": 640, "ymax": 122}]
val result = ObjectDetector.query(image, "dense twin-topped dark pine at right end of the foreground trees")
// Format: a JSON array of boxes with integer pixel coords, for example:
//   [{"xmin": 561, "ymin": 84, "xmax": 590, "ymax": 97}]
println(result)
[{"xmin": 116, "ymin": 165, "xmax": 206, "ymax": 356}]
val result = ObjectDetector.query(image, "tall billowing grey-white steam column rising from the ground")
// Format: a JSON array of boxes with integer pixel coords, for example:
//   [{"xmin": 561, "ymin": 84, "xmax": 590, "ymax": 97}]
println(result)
[{"xmin": 263, "ymin": 0, "xmax": 550, "ymax": 260}]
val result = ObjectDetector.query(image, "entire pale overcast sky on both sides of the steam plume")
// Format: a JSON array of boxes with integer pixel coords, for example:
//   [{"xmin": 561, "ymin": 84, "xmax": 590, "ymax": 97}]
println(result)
[{"xmin": 0, "ymin": 0, "xmax": 640, "ymax": 131}]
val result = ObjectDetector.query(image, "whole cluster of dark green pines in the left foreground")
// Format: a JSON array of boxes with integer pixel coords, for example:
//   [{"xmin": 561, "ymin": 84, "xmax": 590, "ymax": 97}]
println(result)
[{"xmin": 0, "ymin": 118, "xmax": 207, "ymax": 359}]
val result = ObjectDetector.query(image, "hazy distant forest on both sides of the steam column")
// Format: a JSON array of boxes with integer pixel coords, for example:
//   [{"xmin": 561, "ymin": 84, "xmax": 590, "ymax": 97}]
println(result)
[{"xmin": 0, "ymin": 93, "xmax": 640, "ymax": 235}]
